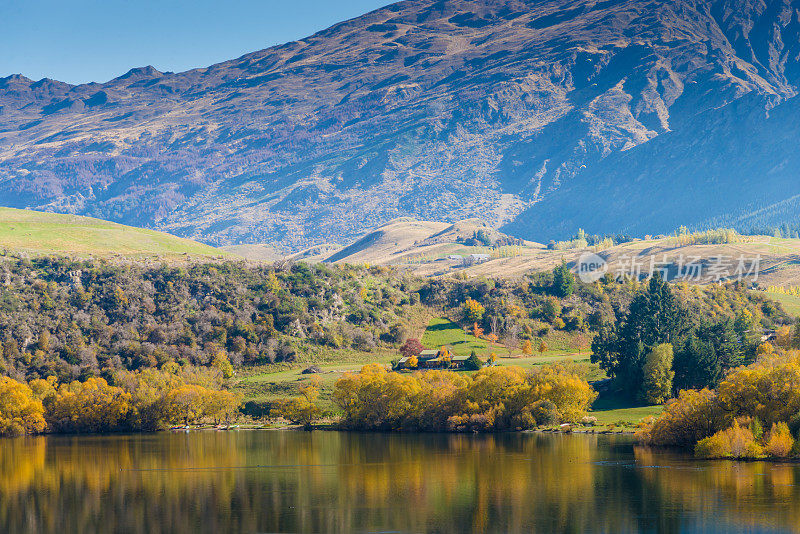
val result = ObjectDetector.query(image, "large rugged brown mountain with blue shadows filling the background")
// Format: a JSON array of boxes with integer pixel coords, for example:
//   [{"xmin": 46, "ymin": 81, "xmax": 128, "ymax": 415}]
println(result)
[{"xmin": 0, "ymin": 0, "xmax": 800, "ymax": 250}]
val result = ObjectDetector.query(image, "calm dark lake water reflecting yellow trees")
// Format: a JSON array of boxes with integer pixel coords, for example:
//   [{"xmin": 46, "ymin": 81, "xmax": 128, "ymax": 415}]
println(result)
[{"xmin": 0, "ymin": 431, "xmax": 800, "ymax": 534}]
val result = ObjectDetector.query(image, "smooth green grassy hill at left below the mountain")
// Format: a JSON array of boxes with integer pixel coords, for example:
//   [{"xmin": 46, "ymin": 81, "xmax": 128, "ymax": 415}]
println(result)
[{"xmin": 0, "ymin": 208, "xmax": 226, "ymax": 256}]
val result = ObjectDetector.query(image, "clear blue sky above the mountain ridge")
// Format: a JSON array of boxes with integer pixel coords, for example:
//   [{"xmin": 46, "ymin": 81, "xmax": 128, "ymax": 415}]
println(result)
[{"xmin": 0, "ymin": 0, "xmax": 393, "ymax": 83}]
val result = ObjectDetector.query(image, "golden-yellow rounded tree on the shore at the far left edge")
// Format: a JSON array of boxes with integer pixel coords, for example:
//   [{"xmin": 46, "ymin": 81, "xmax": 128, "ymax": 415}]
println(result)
[{"xmin": 0, "ymin": 377, "xmax": 46, "ymax": 436}]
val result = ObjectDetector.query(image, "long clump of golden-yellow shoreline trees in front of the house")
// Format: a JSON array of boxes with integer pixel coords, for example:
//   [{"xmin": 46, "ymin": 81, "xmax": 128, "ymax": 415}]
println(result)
[{"xmin": 334, "ymin": 365, "xmax": 596, "ymax": 431}]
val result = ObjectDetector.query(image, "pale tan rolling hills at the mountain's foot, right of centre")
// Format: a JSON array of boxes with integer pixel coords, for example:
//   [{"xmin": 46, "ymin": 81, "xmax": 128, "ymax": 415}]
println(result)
[{"xmin": 308, "ymin": 218, "xmax": 800, "ymax": 287}]
